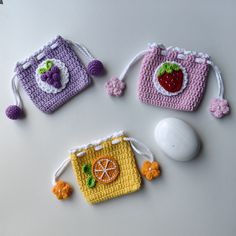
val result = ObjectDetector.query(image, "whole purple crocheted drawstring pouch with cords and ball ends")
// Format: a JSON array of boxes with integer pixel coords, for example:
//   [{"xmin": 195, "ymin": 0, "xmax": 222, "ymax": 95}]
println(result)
[{"xmin": 6, "ymin": 36, "xmax": 104, "ymax": 120}]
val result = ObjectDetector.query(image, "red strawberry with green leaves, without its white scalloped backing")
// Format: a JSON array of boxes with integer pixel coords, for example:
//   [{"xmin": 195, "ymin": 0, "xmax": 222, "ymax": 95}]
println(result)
[{"xmin": 156, "ymin": 62, "xmax": 184, "ymax": 93}]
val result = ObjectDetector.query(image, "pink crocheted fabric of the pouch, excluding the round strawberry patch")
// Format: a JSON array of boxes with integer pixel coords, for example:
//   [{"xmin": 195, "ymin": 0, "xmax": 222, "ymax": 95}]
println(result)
[{"xmin": 138, "ymin": 46, "xmax": 209, "ymax": 111}]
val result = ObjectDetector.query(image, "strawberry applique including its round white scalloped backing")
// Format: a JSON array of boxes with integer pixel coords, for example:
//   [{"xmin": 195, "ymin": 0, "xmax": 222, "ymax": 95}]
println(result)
[{"xmin": 153, "ymin": 62, "xmax": 187, "ymax": 96}]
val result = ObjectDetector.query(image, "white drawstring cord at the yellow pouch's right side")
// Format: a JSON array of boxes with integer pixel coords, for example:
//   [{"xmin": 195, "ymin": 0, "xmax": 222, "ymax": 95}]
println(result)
[{"xmin": 124, "ymin": 137, "xmax": 154, "ymax": 162}]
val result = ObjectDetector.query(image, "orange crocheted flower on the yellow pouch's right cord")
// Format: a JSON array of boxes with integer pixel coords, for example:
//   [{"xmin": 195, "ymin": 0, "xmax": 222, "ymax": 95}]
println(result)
[{"xmin": 141, "ymin": 161, "xmax": 161, "ymax": 181}]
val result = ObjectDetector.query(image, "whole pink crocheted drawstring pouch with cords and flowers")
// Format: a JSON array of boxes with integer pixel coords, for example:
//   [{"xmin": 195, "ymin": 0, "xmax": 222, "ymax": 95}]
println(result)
[{"xmin": 105, "ymin": 44, "xmax": 230, "ymax": 118}]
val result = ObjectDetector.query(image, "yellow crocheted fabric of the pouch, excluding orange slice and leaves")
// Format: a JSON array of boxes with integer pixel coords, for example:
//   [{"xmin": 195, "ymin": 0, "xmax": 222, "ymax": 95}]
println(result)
[{"xmin": 70, "ymin": 135, "xmax": 141, "ymax": 203}]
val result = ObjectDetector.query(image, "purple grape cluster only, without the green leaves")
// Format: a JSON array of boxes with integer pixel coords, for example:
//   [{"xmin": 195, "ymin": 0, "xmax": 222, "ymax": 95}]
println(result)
[{"xmin": 41, "ymin": 66, "xmax": 62, "ymax": 89}]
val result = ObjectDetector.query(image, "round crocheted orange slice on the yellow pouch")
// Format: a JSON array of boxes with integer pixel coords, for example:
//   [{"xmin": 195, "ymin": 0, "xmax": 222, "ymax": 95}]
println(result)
[{"xmin": 92, "ymin": 157, "xmax": 120, "ymax": 184}]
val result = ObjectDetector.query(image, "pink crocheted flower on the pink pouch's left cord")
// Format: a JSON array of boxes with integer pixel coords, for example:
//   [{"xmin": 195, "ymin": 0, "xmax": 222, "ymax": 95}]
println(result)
[{"xmin": 105, "ymin": 77, "xmax": 125, "ymax": 96}]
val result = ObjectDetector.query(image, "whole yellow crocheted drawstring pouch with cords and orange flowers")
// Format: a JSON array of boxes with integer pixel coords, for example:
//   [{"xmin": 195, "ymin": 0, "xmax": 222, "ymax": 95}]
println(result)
[{"xmin": 52, "ymin": 131, "xmax": 160, "ymax": 204}]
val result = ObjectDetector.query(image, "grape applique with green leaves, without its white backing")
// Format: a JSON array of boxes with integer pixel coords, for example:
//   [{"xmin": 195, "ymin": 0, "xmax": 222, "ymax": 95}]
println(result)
[{"xmin": 38, "ymin": 60, "xmax": 62, "ymax": 89}]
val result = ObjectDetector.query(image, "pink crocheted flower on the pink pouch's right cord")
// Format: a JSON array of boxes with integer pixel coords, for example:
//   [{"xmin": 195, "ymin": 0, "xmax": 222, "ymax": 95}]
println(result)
[{"xmin": 209, "ymin": 98, "xmax": 230, "ymax": 118}]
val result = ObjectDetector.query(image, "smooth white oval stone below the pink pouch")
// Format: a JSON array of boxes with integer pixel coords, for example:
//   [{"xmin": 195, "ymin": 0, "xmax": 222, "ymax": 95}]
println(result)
[{"xmin": 154, "ymin": 118, "xmax": 200, "ymax": 161}]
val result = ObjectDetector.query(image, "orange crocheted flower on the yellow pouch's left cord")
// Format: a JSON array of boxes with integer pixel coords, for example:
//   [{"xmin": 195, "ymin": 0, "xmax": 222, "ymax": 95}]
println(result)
[{"xmin": 52, "ymin": 180, "xmax": 72, "ymax": 200}]
